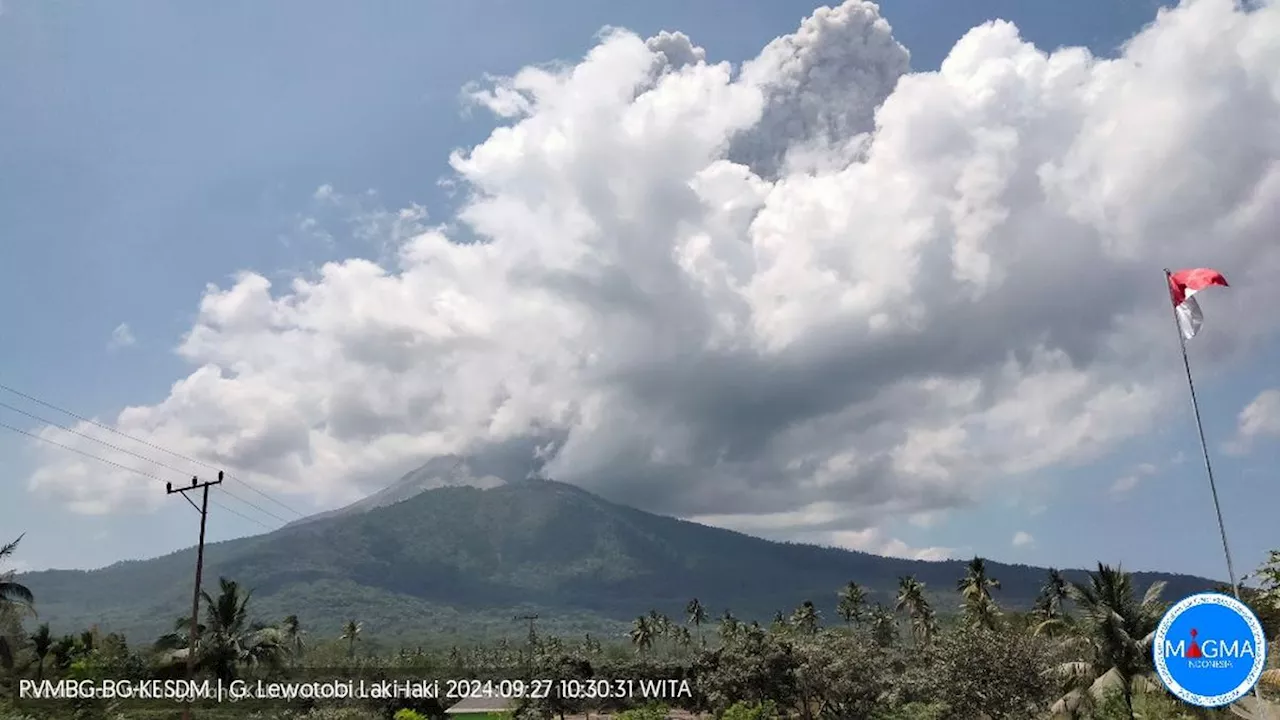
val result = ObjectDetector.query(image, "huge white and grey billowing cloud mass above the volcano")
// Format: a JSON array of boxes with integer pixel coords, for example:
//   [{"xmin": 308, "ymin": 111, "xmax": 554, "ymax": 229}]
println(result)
[{"xmin": 22, "ymin": 0, "xmax": 1280, "ymax": 552}]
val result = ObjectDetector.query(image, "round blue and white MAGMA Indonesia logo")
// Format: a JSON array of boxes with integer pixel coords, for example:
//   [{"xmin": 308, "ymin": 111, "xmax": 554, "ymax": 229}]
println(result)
[{"xmin": 1152, "ymin": 592, "xmax": 1267, "ymax": 707}]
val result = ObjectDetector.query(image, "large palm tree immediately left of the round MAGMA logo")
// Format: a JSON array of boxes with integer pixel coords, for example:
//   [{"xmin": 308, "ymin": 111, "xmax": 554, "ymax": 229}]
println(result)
[{"xmin": 1053, "ymin": 562, "xmax": 1165, "ymax": 717}]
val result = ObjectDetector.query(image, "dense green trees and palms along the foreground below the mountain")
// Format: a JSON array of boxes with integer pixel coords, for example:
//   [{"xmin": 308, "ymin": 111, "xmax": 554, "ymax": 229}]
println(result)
[{"xmin": 0, "ymin": 530, "xmax": 1280, "ymax": 720}]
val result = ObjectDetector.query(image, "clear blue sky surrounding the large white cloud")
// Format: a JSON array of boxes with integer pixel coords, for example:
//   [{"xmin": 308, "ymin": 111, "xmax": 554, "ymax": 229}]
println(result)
[{"xmin": 0, "ymin": 0, "xmax": 1280, "ymax": 577}]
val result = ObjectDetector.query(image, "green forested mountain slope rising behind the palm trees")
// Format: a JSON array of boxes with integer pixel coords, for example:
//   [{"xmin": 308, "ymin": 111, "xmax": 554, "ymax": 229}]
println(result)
[{"xmin": 22, "ymin": 480, "xmax": 1215, "ymax": 642}]
